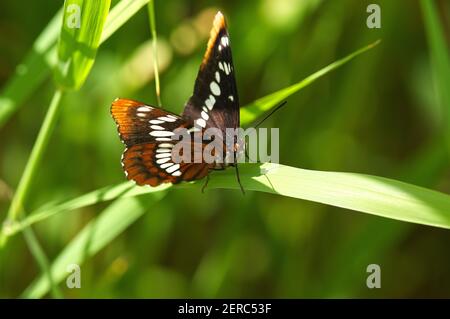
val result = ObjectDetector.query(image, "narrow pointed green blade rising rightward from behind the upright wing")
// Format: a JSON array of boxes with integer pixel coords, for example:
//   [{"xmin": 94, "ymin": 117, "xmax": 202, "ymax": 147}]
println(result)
[{"xmin": 241, "ymin": 40, "xmax": 380, "ymax": 127}]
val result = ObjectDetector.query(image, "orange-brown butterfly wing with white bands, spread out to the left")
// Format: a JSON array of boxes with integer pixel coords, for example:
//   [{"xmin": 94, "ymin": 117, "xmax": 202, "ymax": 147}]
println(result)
[{"xmin": 111, "ymin": 99, "xmax": 209, "ymax": 186}]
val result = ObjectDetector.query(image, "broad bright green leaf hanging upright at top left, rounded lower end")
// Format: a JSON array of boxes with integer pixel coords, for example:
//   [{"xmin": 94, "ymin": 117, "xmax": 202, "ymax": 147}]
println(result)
[{"xmin": 55, "ymin": 0, "xmax": 111, "ymax": 90}]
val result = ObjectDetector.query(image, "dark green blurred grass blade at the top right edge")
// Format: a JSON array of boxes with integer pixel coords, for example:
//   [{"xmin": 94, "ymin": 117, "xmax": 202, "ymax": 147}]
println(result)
[{"xmin": 421, "ymin": 0, "xmax": 450, "ymax": 142}]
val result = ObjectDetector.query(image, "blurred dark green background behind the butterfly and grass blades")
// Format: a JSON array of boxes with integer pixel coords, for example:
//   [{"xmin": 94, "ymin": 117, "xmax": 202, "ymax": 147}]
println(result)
[{"xmin": 0, "ymin": 0, "xmax": 450, "ymax": 298}]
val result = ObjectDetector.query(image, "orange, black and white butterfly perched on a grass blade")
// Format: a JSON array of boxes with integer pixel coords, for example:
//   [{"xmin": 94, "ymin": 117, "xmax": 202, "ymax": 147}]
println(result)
[{"xmin": 111, "ymin": 12, "xmax": 244, "ymax": 192}]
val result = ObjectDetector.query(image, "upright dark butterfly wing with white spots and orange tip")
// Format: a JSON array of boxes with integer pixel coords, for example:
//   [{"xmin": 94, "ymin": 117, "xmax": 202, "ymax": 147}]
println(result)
[{"xmin": 183, "ymin": 12, "xmax": 239, "ymax": 136}]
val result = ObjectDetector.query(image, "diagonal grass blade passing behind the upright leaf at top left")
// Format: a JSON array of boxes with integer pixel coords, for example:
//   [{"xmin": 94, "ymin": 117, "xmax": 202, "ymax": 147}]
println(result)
[{"xmin": 0, "ymin": 0, "xmax": 149, "ymax": 127}]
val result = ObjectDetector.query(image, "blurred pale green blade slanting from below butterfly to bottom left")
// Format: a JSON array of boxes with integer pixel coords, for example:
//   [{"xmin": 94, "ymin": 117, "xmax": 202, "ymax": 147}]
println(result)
[{"xmin": 21, "ymin": 192, "xmax": 165, "ymax": 298}]
